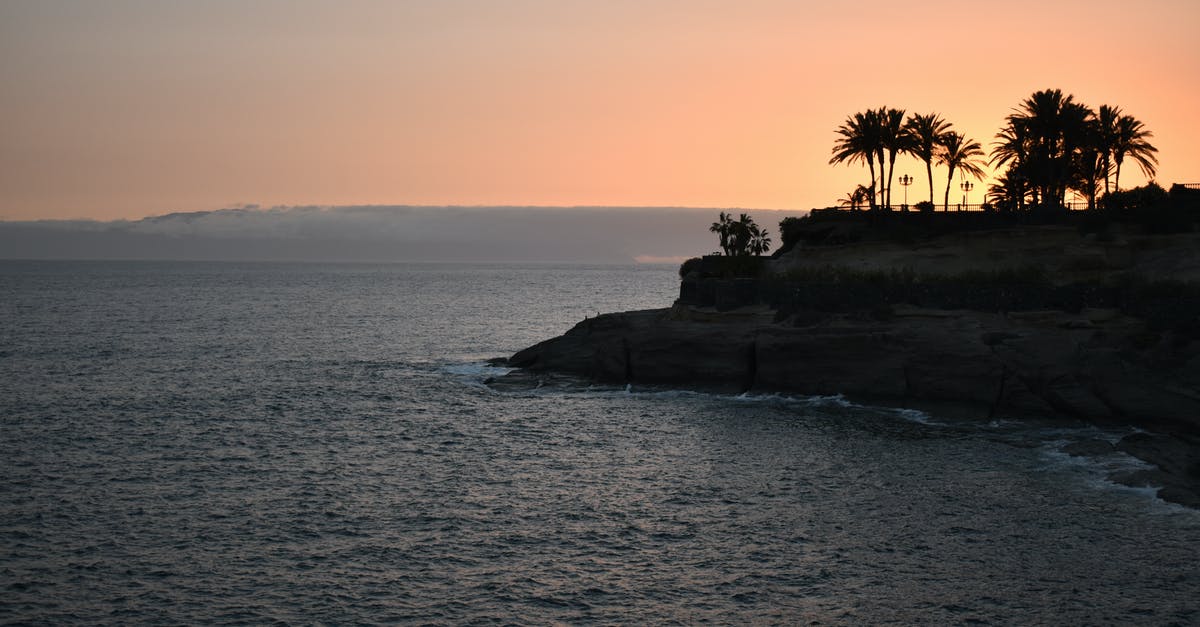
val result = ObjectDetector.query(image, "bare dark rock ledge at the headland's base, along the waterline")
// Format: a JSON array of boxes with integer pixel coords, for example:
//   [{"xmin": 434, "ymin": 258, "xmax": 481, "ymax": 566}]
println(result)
[{"xmin": 497, "ymin": 304, "xmax": 1200, "ymax": 508}]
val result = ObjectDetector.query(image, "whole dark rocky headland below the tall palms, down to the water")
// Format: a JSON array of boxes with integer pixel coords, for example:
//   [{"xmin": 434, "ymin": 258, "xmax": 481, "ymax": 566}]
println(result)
[{"xmin": 497, "ymin": 205, "xmax": 1200, "ymax": 507}]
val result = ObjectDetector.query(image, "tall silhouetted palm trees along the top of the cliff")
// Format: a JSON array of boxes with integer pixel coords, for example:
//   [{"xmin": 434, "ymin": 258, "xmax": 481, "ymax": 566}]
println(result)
[{"xmin": 829, "ymin": 89, "xmax": 1158, "ymax": 210}]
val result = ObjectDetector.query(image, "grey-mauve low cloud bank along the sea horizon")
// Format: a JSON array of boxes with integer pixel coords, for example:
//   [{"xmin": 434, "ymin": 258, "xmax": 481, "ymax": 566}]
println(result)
[{"xmin": 0, "ymin": 205, "xmax": 799, "ymax": 263}]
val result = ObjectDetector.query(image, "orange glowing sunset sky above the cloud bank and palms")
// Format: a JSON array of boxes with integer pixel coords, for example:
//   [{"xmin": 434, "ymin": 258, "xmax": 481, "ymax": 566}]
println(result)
[{"xmin": 0, "ymin": 0, "xmax": 1200, "ymax": 220}]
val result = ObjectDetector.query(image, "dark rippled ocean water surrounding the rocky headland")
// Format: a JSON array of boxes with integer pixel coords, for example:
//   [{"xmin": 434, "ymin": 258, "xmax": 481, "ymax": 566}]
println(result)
[{"xmin": 0, "ymin": 261, "xmax": 1200, "ymax": 625}]
